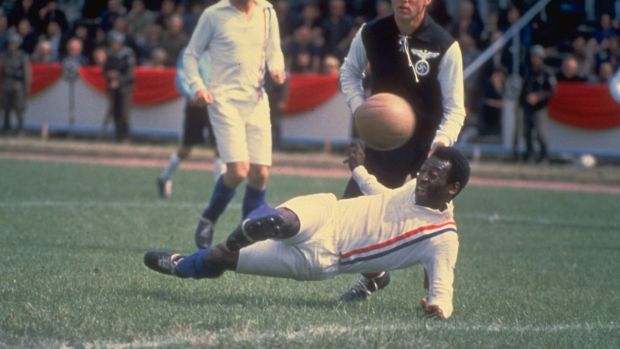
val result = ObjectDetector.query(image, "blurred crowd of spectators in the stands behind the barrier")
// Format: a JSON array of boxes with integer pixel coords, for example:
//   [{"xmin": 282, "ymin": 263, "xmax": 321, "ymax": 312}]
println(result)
[{"xmin": 0, "ymin": 0, "xmax": 620, "ymax": 139}]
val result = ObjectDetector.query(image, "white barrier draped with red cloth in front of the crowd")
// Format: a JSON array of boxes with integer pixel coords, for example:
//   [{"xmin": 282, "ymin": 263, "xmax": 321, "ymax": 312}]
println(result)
[{"xmin": 19, "ymin": 64, "xmax": 620, "ymax": 156}]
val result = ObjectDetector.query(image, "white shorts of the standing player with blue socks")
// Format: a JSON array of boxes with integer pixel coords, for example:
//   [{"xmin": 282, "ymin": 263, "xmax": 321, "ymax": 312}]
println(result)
[{"xmin": 209, "ymin": 93, "xmax": 271, "ymax": 166}]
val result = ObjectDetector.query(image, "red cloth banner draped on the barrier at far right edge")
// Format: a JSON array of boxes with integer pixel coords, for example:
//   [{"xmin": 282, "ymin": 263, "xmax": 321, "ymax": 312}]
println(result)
[{"xmin": 549, "ymin": 82, "xmax": 620, "ymax": 130}]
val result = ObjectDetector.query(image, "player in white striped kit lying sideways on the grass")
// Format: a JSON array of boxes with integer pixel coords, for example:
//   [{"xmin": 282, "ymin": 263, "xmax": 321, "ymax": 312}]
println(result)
[{"xmin": 144, "ymin": 144, "xmax": 469, "ymax": 319}]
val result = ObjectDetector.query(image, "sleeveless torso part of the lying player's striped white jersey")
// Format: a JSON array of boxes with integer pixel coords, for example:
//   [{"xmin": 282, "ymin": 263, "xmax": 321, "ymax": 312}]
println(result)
[{"xmin": 334, "ymin": 181, "xmax": 456, "ymax": 273}]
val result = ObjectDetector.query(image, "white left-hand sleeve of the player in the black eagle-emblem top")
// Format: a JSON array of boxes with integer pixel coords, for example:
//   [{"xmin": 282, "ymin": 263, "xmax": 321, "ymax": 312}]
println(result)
[{"xmin": 339, "ymin": 25, "xmax": 368, "ymax": 114}]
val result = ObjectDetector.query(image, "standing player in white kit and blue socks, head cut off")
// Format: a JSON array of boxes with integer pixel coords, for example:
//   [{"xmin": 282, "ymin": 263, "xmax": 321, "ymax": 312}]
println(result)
[{"xmin": 183, "ymin": 0, "xmax": 286, "ymax": 248}]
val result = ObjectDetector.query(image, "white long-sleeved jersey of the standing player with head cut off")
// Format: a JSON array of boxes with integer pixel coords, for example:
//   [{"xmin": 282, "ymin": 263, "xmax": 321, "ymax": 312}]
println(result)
[{"xmin": 183, "ymin": 0, "xmax": 284, "ymax": 100}]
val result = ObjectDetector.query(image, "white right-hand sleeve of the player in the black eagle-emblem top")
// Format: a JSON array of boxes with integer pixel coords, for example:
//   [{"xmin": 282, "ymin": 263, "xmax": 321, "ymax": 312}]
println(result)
[{"xmin": 433, "ymin": 41, "xmax": 465, "ymax": 146}]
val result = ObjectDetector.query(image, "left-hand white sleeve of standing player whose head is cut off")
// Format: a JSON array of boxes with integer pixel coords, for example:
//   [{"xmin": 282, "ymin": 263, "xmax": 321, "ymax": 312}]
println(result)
[{"xmin": 183, "ymin": 11, "xmax": 214, "ymax": 95}]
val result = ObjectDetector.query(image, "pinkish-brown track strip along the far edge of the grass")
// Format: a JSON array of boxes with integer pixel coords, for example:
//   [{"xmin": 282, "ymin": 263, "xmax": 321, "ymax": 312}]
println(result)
[{"xmin": 0, "ymin": 151, "xmax": 620, "ymax": 194}]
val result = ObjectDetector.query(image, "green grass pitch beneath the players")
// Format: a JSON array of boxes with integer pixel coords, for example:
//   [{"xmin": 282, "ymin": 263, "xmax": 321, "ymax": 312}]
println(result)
[{"xmin": 0, "ymin": 160, "xmax": 620, "ymax": 348}]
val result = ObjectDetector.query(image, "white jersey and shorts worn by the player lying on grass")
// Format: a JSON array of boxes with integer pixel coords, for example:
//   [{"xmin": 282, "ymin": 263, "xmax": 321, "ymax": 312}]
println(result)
[{"xmin": 236, "ymin": 167, "xmax": 459, "ymax": 317}]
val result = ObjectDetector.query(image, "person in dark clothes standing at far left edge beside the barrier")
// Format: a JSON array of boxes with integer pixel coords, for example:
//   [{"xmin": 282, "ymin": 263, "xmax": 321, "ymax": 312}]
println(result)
[{"xmin": 0, "ymin": 32, "xmax": 31, "ymax": 133}]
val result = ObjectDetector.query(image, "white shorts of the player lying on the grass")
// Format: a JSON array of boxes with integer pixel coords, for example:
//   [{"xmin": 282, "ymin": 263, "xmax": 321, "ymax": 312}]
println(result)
[{"xmin": 236, "ymin": 194, "xmax": 339, "ymax": 280}]
